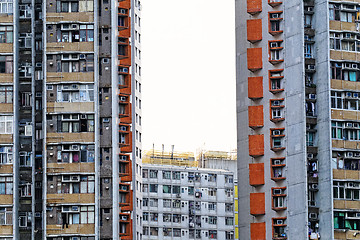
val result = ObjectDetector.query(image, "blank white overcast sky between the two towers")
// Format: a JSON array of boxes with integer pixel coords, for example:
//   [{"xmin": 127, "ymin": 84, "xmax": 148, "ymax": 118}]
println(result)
[{"xmin": 141, "ymin": 0, "xmax": 236, "ymax": 151}]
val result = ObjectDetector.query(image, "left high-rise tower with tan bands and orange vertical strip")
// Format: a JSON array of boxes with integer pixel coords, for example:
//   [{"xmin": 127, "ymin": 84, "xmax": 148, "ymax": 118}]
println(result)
[{"xmin": 0, "ymin": 0, "xmax": 142, "ymax": 240}]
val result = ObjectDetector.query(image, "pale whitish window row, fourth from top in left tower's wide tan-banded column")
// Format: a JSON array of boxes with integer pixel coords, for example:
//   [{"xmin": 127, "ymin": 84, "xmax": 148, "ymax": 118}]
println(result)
[{"xmin": 57, "ymin": 84, "xmax": 94, "ymax": 102}]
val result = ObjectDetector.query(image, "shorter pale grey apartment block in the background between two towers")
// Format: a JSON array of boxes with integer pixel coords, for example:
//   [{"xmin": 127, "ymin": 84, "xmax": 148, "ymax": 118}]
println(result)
[{"xmin": 139, "ymin": 164, "xmax": 235, "ymax": 239}]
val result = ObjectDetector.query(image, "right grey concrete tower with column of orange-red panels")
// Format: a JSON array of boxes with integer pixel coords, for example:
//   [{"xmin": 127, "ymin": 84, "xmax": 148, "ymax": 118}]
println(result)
[{"xmin": 236, "ymin": 0, "xmax": 360, "ymax": 240}]
